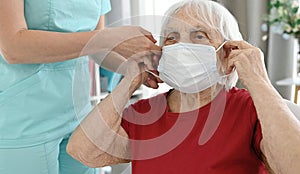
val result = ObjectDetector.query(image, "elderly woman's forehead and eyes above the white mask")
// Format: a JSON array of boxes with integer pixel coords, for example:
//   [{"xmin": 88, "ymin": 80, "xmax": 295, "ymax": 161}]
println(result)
[{"xmin": 164, "ymin": 11, "xmax": 223, "ymax": 48}]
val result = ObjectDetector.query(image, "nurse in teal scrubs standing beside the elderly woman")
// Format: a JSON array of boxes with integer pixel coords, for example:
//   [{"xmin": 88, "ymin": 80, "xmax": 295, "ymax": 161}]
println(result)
[{"xmin": 0, "ymin": 0, "xmax": 160, "ymax": 174}]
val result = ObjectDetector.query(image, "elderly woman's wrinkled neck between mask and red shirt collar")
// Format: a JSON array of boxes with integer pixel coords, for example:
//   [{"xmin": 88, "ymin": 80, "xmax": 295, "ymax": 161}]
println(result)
[{"xmin": 167, "ymin": 85, "xmax": 223, "ymax": 113}]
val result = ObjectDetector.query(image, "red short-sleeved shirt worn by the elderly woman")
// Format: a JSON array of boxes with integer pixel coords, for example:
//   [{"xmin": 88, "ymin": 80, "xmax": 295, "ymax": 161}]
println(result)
[{"xmin": 122, "ymin": 88, "xmax": 268, "ymax": 174}]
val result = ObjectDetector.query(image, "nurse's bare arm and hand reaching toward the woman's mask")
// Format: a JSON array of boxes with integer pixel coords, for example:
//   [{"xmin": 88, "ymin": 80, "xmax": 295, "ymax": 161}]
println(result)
[{"xmin": 0, "ymin": 0, "xmax": 160, "ymax": 64}]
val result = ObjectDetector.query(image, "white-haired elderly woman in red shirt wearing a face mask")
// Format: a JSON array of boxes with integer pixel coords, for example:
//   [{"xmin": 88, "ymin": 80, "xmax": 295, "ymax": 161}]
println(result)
[{"xmin": 68, "ymin": 0, "xmax": 300, "ymax": 174}]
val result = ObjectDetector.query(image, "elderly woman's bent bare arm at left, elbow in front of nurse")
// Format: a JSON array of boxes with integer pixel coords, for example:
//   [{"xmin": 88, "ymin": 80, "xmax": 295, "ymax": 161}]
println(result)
[{"xmin": 67, "ymin": 77, "xmax": 137, "ymax": 167}]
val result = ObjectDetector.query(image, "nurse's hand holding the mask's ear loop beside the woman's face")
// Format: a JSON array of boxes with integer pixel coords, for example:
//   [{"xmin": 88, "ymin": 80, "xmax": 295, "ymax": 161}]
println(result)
[{"xmin": 113, "ymin": 26, "xmax": 162, "ymax": 89}]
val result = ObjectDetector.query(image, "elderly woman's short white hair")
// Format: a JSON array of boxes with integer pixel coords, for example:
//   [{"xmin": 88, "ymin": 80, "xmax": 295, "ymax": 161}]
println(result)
[{"xmin": 160, "ymin": 0, "xmax": 243, "ymax": 90}]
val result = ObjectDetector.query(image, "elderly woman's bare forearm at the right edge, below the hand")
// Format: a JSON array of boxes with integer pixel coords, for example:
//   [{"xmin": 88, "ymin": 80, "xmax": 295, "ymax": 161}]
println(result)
[{"xmin": 249, "ymin": 81, "xmax": 300, "ymax": 174}]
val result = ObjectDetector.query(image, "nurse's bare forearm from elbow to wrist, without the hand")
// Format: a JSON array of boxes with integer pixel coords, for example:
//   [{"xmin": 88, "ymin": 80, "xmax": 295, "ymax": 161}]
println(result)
[{"xmin": 1, "ymin": 29, "xmax": 115, "ymax": 64}]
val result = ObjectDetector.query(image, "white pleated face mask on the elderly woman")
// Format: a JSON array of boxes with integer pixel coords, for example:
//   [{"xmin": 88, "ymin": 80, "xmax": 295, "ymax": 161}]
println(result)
[{"xmin": 158, "ymin": 42, "xmax": 225, "ymax": 93}]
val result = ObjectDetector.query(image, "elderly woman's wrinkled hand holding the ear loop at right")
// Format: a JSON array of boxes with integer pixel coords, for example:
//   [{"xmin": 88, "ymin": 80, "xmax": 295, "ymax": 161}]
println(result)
[{"xmin": 224, "ymin": 41, "xmax": 270, "ymax": 89}]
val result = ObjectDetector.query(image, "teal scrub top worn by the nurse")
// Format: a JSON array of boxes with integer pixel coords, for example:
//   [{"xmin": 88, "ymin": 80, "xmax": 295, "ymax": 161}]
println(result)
[{"xmin": 0, "ymin": 0, "xmax": 111, "ymax": 148}]
